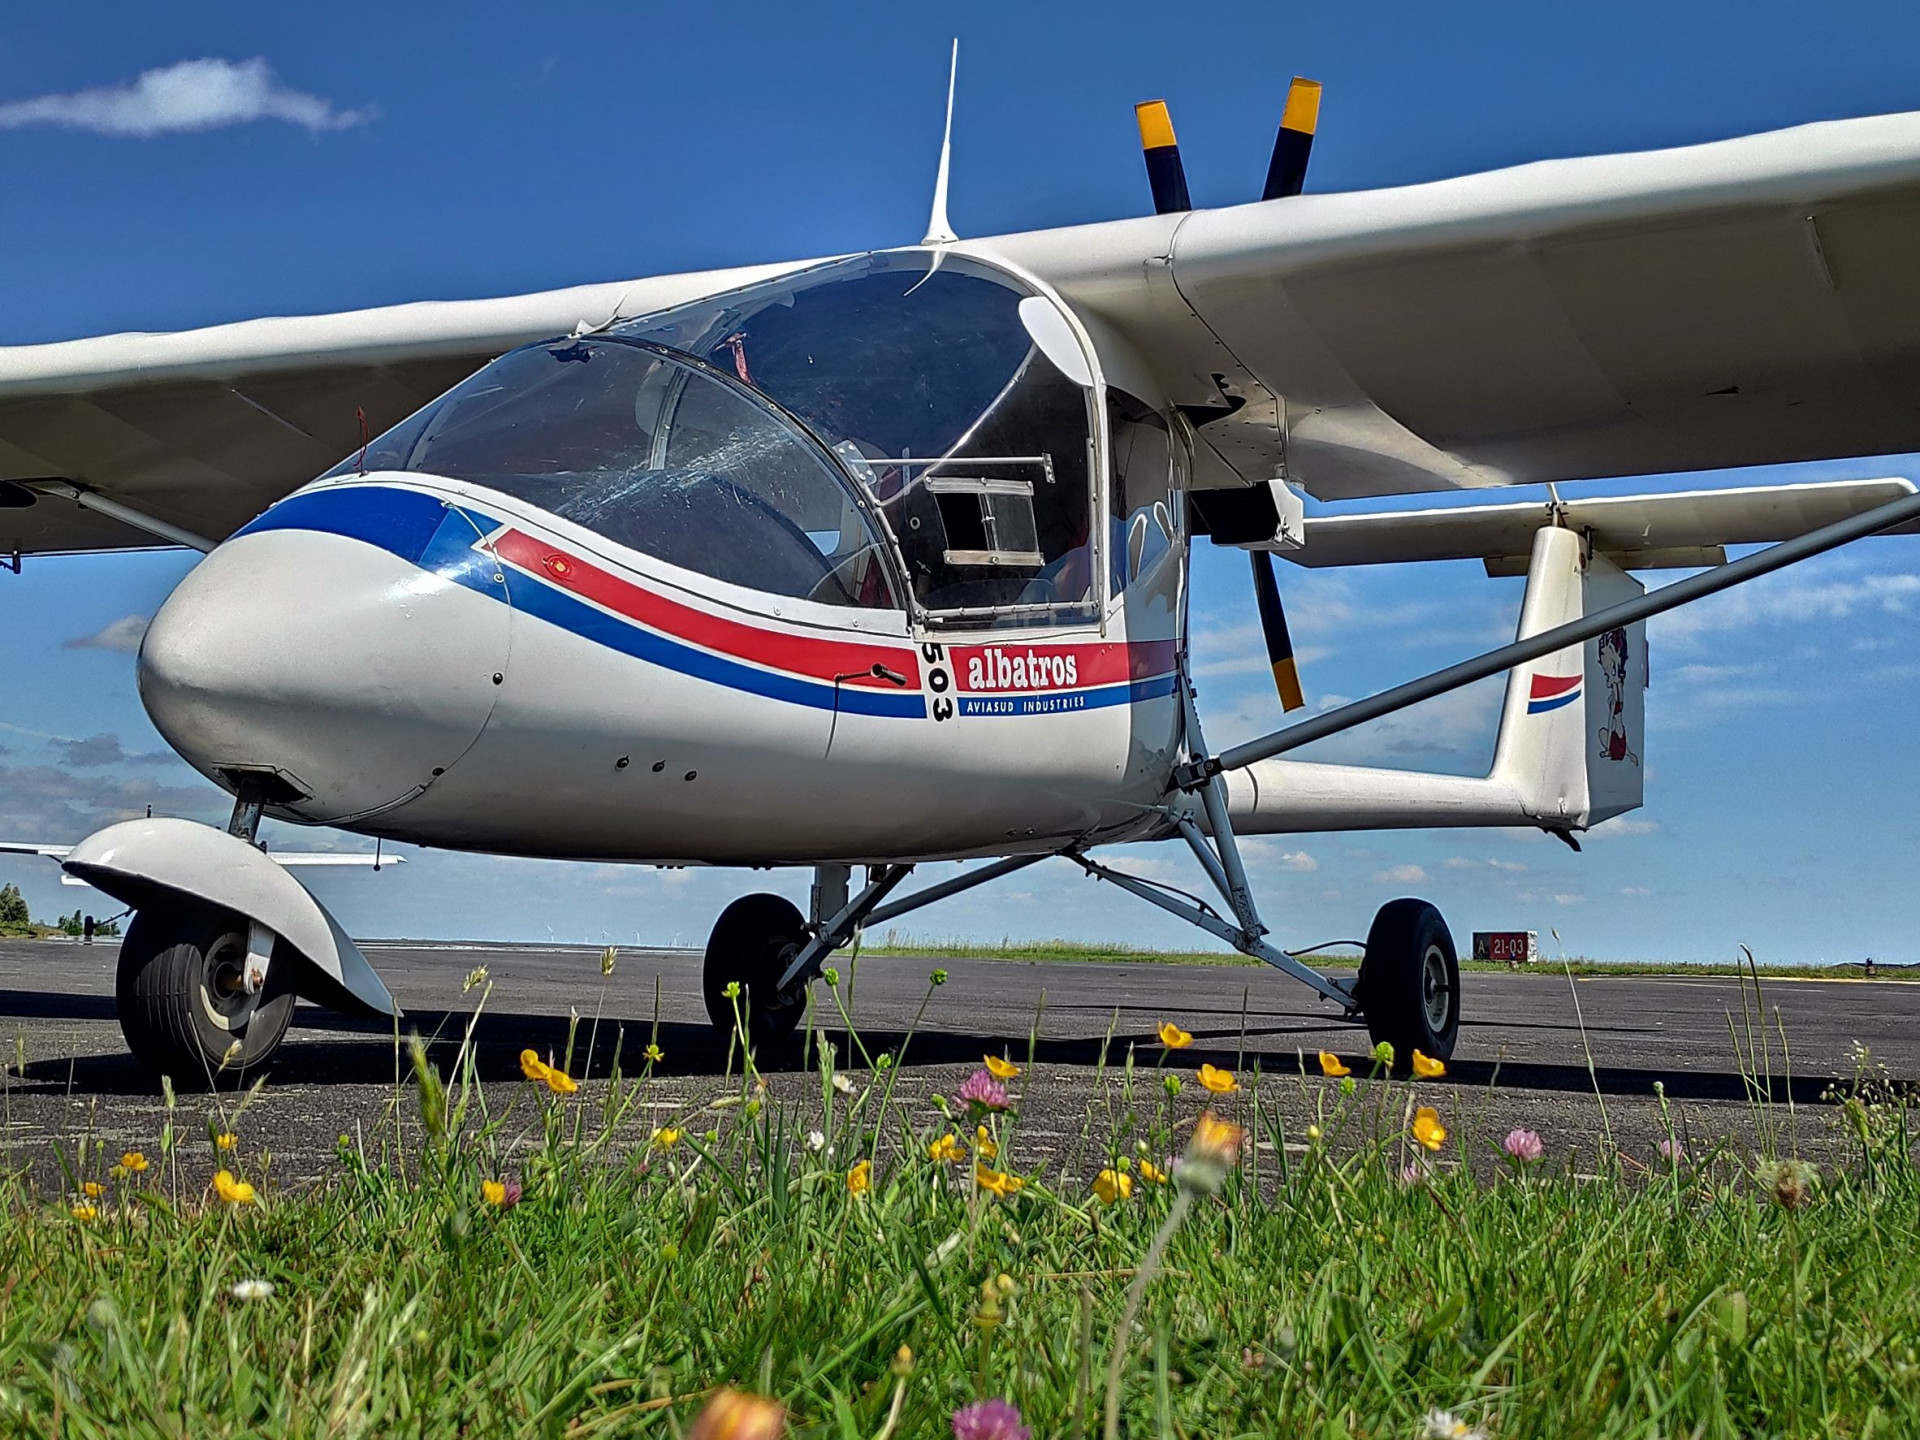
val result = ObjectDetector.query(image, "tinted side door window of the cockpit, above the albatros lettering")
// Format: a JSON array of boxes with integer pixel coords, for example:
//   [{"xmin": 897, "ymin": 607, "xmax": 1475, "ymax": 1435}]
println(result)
[{"xmin": 614, "ymin": 250, "xmax": 1098, "ymax": 622}]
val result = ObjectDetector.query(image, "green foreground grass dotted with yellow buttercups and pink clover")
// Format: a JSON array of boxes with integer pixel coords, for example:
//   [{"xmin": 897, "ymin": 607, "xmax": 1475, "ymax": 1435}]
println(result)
[{"xmin": 0, "ymin": 975, "xmax": 1920, "ymax": 1440}]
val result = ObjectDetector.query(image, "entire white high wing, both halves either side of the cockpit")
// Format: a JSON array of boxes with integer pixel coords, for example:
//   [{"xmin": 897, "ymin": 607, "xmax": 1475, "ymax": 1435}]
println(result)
[{"xmin": 0, "ymin": 113, "xmax": 1920, "ymax": 553}]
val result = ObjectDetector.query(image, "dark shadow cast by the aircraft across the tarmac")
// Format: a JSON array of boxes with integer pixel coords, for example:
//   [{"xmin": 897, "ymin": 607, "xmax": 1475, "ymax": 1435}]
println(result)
[{"xmin": 0, "ymin": 991, "xmax": 1834, "ymax": 1104}]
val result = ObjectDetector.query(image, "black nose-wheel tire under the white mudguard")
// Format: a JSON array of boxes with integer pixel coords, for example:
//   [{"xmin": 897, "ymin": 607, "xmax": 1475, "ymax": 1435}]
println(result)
[{"xmin": 113, "ymin": 904, "xmax": 296, "ymax": 1091}]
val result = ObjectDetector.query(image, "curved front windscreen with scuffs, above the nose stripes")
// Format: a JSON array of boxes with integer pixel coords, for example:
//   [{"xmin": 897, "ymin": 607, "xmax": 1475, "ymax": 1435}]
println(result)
[{"xmin": 334, "ymin": 338, "xmax": 899, "ymax": 609}]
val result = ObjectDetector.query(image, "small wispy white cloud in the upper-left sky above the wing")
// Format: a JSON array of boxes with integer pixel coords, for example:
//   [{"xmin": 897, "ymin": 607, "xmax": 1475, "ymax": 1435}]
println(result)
[{"xmin": 0, "ymin": 56, "xmax": 376, "ymax": 136}]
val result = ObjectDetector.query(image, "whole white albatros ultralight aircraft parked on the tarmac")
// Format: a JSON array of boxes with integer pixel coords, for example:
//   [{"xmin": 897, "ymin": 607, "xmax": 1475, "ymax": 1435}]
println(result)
[{"xmin": 0, "ymin": 67, "xmax": 1920, "ymax": 1083}]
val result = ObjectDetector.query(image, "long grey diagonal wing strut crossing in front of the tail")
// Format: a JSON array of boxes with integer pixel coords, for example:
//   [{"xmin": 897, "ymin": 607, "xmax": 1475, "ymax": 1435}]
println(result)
[{"xmin": 1173, "ymin": 481, "xmax": 1920, "ymax": 795}]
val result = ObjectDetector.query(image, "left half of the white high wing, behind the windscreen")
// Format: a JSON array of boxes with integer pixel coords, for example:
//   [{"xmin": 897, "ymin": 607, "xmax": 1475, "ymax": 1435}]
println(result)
[{"xmin": 0, "ymin": 265, "xmax": 810, "ymax": 555}]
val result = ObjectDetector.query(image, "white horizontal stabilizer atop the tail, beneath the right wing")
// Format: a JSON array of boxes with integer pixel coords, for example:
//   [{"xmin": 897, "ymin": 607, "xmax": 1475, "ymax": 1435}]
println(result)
[{"xmin": 1261, "ymin": 478, "xmax": 1916, "ymax": 574}]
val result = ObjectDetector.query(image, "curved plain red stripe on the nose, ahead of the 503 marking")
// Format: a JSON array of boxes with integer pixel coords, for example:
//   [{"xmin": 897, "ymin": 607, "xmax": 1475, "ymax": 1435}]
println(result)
[{"xmin": 493, "ymin": 530, "xmax": 920, "ymax": 689}]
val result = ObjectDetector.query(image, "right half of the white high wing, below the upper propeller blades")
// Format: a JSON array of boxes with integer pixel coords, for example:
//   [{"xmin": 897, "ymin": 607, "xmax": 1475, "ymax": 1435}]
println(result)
[{"xmin": 996, "ymin": 113, "xmax": 1920, "ymax": 499}]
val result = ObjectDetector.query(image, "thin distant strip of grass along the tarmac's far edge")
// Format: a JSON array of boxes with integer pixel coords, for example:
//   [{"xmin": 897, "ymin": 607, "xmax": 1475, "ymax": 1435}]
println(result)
[{"xmin": 862, "ymin": 929, "xmax": 1920, "ymax": 979}]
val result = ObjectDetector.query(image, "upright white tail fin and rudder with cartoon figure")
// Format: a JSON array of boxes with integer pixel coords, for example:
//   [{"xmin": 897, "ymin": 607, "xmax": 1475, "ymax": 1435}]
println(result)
[{"xmin": 1490, "ymin": 528, "xmax": 1647, "ymax": 829}]
